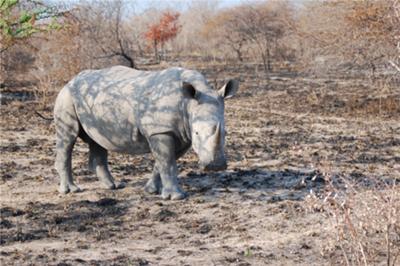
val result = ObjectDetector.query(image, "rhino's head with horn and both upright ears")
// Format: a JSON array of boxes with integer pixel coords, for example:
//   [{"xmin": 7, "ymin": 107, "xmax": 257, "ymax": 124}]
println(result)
[{"xmin": 183, "ymin": 80, "xmax": 239, "ymax": 171}]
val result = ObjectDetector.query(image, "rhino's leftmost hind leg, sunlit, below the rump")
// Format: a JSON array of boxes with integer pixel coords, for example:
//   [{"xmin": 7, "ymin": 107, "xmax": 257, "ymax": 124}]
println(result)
[{"xmin": 54, "ymin": 89, "xmax": 80, "ymax": 194}]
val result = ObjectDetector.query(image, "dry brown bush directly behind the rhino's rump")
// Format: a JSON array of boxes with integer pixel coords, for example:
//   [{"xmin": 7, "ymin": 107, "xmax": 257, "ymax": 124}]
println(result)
[{"xmin": 30, "ymin": 8, "xmax": 86, "ymax": 109}]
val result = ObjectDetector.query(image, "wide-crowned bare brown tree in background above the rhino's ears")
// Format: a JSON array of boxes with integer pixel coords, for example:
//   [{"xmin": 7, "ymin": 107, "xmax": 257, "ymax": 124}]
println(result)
[{"xmin": 208, "ymin": 1, "xmax": 292, "ymax": 73}]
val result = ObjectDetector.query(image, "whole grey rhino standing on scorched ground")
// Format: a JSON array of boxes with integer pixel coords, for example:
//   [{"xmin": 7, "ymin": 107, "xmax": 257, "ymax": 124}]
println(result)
[{"xmin": 54, "ymin": 66, "xmax": 238, "ymax": 199}]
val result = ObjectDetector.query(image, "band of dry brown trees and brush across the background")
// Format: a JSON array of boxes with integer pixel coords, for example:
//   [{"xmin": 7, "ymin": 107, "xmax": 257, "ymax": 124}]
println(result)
[{"xmin": 0, "ymin": 0, "xmax": 400, "ymax": 86}]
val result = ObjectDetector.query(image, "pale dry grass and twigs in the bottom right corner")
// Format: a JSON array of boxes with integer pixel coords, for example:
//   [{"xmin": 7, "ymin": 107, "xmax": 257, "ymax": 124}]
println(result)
[{"xmin": 306, "ymin": 172, "xmax": 400, "ymax": 266}]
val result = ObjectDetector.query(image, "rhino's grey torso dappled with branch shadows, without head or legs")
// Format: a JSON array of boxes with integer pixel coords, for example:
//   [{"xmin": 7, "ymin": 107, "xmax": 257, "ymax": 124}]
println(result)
[{"xmin": 69, "ymin": 66, "xmax": 192, "ymax": 154}]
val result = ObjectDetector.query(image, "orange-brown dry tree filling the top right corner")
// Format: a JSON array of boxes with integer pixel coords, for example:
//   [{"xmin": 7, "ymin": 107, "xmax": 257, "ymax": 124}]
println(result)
[{"xmin": 296, "ymin": 0, "xmax": 400, "ymax": 77}]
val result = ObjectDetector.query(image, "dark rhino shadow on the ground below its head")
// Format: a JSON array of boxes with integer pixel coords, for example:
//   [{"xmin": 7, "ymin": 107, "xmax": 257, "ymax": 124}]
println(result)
[{"xmin": 180, "ymin": 169, "xmax": 325, "ymax": 201}]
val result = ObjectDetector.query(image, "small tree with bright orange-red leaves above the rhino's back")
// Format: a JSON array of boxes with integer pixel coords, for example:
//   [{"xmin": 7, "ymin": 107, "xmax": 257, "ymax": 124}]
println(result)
[{"xmin": 145, "ymin": 11, "xmax": 181, "ymax": 61}]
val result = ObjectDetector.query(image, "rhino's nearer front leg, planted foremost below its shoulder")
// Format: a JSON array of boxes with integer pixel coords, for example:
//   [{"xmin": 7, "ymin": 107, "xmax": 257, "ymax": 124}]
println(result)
[{"xmin": 149, "ymin": 134, "xmax": 186, "ymax": 200}]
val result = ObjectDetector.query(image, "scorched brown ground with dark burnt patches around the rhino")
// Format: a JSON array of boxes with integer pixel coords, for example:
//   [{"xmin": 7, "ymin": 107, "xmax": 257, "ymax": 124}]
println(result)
[{"xmin": 0, "ymin": 65, "xmax": 400, "ymax": 265}]
